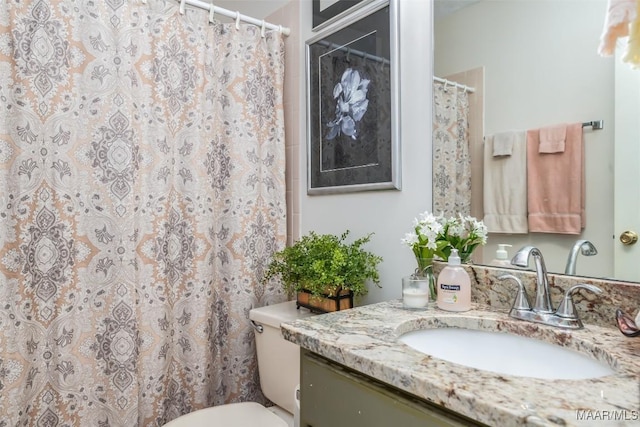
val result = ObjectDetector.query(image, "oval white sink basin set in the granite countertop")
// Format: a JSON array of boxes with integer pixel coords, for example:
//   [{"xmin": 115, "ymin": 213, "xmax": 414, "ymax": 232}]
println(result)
[{"xmin": 399, "ymin": 328, "xmax": 615, "ymax": 380}]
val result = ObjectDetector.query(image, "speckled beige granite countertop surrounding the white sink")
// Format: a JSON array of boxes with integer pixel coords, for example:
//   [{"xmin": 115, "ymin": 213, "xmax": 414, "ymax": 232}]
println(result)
[{"xmin": 281, "ymin": 300, "xmax": 640, "ymax": 427}]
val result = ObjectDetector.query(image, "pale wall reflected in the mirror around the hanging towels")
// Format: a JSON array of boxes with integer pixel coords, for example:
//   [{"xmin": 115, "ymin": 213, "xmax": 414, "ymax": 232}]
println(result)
[{"xmin": 435, "ymin": 0, "xmax": 614, "ymax": 276}]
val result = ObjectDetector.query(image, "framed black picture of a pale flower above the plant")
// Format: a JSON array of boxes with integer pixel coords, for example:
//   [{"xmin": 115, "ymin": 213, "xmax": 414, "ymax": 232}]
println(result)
[{"xmin": 306, "ymin": 0, "xmax": 401, "ymax": 194}]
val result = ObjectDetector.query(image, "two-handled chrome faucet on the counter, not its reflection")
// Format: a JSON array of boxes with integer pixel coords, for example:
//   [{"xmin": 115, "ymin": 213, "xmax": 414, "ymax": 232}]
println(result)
[{"xmin": 498, "ymin": 246, "xmax": 602, "ymax": 329}]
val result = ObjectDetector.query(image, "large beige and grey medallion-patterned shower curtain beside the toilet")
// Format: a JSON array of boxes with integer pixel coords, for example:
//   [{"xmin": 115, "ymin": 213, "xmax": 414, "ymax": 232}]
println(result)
[{"xmin": 0, "ymin": 0, "xmax": 286, "ymax": 427}]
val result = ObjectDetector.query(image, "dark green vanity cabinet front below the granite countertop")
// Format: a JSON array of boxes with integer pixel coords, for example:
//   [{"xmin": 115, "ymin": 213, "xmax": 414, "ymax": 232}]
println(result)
[{"xmin": 300, "ymin": 350, "xmax": 482, "ymax": 427}]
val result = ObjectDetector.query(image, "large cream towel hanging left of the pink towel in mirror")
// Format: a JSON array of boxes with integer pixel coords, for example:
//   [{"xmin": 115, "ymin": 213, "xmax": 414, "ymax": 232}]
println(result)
[{"xmin": 484, "ymin": 130, "xmax": 528, "ymax": 234}]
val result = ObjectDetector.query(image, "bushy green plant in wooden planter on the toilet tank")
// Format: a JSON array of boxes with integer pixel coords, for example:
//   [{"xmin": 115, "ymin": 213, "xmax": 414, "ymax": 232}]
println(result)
[{"xmin": 265, "ymin": 230, "xmax": 382, "ymax": 312}]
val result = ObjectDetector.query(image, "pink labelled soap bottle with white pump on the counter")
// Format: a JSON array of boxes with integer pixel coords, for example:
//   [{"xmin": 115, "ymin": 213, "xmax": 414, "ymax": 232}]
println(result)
[{"xmin": 437, "ymin": 248, "xmax": 471, "ymax": 311}]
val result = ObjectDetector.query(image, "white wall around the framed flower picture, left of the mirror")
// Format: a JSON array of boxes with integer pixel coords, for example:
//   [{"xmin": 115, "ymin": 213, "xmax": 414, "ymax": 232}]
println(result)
[{"xmin": 300, "ymin": 0, "xmax": 432, "ymax": 303}]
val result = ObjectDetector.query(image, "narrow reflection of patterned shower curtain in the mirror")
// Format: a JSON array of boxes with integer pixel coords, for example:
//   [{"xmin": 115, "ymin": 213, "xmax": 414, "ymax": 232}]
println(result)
[{"xmin": 433, "ymin": 82, "xmax": 471, "ymax": 217}]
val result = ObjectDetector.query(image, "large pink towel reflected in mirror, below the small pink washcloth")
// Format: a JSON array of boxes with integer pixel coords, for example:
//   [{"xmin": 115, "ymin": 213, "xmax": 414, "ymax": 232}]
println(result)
[{"xmin": 527, "ymin": 123, "xmax": 585, "ymax": 234}]
